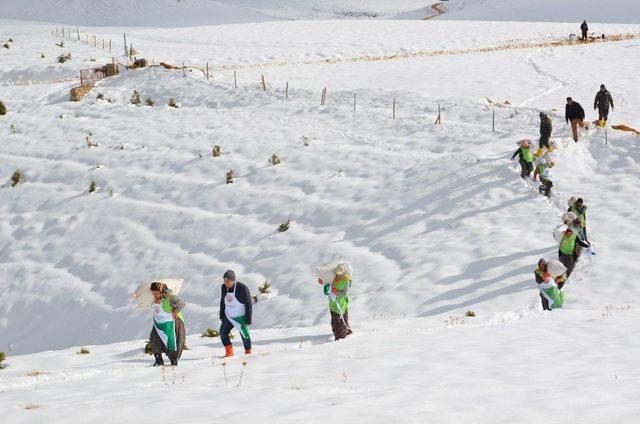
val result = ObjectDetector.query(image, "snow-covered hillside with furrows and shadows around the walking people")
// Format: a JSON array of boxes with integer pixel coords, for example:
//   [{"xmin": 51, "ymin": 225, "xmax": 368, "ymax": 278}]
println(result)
[{"xmin": 0, "ymin": 6, "xmax": 640, "ymax": 424}]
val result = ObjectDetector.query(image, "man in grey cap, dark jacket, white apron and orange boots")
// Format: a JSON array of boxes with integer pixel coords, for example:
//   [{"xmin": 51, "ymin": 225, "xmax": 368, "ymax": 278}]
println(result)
[{"xmin": 220, "ymin": 270, "xmax": 253, "ymax": 357}]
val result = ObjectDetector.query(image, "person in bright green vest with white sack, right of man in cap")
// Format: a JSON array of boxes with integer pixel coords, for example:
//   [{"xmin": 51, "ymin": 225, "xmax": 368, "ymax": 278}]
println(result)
[{"xmin": 318, "ymin": 262, "xmax": 353, "ymax": 340}]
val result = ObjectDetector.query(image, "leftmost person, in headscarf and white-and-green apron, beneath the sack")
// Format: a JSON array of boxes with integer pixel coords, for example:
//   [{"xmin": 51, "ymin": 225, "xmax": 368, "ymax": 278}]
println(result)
[{"xmin": 149, "ymin": 282, "xmax": 186, "ymax": 367}]
